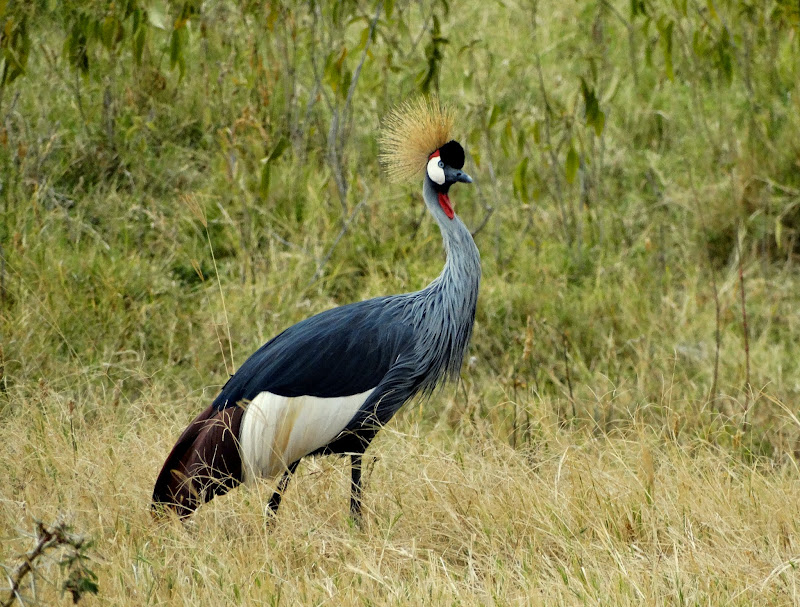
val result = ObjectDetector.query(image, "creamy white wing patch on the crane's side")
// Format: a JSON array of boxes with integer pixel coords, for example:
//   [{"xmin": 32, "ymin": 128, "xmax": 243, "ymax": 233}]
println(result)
[{"xmin": 239, "ymin": 388, "xmax": 375, "ymax": 481}]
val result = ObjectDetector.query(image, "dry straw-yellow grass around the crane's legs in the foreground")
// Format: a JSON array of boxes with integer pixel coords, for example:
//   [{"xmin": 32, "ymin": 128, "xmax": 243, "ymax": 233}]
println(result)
[{"xmin": 0, "ymin": 380, "xmax": 800, "ymax": 605}]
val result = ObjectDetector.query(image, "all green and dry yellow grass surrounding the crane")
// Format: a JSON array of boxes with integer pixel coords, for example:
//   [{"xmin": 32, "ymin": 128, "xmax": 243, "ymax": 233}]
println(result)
[{"xmin": 0, "ymin": 0, "xmax": 800, "ymax": 604}]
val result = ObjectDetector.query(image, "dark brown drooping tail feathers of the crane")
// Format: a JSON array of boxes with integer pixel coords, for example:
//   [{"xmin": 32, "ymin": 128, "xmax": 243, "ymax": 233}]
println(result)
[{"xmin": 152, "ymin": 407, "xmax": 244, "ymax": 518}]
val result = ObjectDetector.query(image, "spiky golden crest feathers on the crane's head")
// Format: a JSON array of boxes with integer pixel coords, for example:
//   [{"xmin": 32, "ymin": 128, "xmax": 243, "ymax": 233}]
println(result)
[{"xmin": 379, "ymin": 97, "xmax": 454, "ymax": 182}]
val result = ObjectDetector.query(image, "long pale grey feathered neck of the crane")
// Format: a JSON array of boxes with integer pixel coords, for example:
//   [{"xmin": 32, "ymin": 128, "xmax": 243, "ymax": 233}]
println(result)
[{"xmin": 411, "ymin": 176, "xmax": 481, "ymax": 392}]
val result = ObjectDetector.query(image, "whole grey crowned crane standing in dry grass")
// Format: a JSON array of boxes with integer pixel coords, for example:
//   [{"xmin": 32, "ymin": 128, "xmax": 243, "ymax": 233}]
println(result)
[{"xmin": 153, "ymin": 101, "xmax": 481, "ymax": 521}]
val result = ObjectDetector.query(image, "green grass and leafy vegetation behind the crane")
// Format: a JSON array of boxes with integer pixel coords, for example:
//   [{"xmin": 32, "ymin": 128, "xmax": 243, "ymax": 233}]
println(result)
[{"xmin": 6, "ymin": 0, "xmax": 800, "ymax": 446}]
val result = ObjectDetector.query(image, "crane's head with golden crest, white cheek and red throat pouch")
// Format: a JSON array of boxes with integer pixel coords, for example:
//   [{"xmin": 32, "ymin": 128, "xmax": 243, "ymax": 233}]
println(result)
[{"xmin": 380, "ymin": 98, "xmax": 472, "ymax": 219}]
